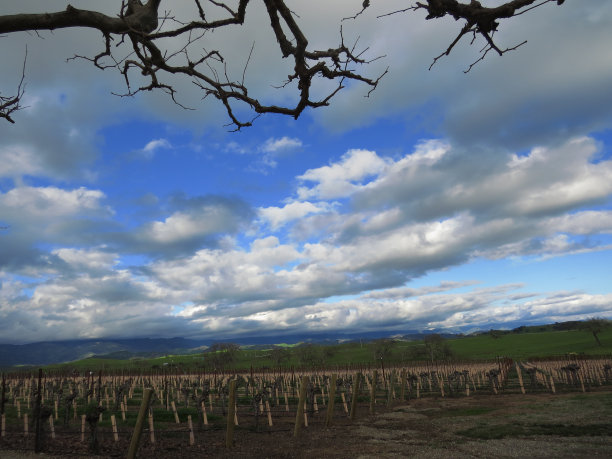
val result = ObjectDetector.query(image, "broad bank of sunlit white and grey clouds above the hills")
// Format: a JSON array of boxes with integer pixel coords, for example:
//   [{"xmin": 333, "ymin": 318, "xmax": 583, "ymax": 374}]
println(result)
[{"xmin": 0, "ymin": 138, "xmax": 612, "ymax": 344}]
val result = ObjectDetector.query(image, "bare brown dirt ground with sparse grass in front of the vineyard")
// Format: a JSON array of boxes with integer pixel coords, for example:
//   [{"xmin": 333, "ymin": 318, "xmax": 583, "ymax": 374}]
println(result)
[{"xmin": 0, "ymin": 391, "xmax": 612, "ymax": 459}]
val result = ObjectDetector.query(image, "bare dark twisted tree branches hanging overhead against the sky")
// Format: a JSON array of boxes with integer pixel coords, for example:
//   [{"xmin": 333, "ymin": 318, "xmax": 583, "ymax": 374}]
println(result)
[{"xmin": 0, "ymin": 0, "xmax": 564, "ymax": 129}]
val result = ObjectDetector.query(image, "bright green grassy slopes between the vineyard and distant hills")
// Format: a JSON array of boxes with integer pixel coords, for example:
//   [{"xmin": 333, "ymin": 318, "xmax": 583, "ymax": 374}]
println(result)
[{"xmin": 40, "ymin": 329, "xmax": 612, "ymax": 371}]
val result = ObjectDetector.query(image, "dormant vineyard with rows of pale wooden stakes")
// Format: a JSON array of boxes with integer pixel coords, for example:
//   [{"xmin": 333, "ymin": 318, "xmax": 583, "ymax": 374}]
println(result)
[{"xmin": 0, "ymin": 358, "xmax": 612, "ymax": 457}]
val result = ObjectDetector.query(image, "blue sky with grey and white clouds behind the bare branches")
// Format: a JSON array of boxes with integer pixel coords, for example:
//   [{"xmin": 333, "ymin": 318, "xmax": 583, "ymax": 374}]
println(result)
[{"xmin": 0, "ymin": 0, "xmax": 612, "ymax": 344}]
